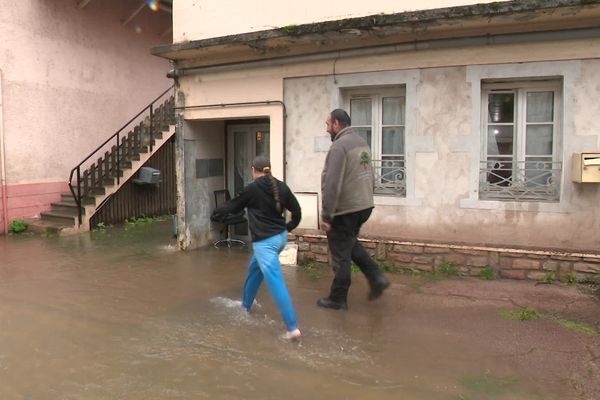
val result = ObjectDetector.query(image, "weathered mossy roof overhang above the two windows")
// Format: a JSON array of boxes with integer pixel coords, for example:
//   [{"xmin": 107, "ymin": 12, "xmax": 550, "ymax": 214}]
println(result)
[{"xmin": 152, "ymin": 0, "xmax": 600, "ymax": 67}]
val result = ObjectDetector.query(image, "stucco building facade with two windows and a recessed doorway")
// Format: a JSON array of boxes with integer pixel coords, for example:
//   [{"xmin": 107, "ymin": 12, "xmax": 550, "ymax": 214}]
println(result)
[{"xmin": 153, "ymin": 0, "xmax": 600, "ymax": 273}]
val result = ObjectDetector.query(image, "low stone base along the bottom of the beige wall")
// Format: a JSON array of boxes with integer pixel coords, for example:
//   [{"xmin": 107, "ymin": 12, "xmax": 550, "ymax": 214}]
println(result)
[{"xmin": 288, "ymin": 233, "xmax": 600, "ymax": 282}]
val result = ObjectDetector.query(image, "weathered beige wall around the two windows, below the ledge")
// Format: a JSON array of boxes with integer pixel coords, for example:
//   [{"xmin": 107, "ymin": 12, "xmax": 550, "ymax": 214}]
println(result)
[{"xmin": 180, "ymin": 39, "xmax": 600, "ymax": 250}]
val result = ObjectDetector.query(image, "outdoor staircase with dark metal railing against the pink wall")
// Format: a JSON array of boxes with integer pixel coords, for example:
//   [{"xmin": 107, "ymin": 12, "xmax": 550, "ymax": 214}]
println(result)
[{"xmin": 29, "ymin": 86, "xmax": 175, "ymax": 234}]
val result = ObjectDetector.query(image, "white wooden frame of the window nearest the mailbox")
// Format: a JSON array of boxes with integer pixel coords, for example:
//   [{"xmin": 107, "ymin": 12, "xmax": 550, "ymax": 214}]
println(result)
[{"xmin": 480, "ymin": 78, "xmax": 562, "ymax": 202}]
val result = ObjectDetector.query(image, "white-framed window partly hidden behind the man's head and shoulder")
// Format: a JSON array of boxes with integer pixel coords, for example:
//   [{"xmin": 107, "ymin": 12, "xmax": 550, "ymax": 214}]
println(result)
[{"xmin": 347, "ymin": 90, "xmax": 406, "ymax": 196}]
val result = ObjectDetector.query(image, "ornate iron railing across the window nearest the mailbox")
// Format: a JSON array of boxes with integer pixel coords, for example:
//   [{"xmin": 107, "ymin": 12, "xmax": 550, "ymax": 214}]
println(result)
[{"xmin": 479, "ymin": 160, "xmax": 562, "ymax": 202}]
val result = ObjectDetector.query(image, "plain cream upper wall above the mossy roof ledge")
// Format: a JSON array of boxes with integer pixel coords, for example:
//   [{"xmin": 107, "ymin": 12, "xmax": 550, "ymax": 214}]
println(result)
[{"xmin": 173, "ymin": 0, "xmax": 506, "ymax": 43}]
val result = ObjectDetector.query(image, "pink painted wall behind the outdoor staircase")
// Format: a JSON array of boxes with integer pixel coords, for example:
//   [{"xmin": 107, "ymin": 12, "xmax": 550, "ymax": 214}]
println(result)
[{"xmin": 0, "ymin": 0, "xmax": 172, "ymax": 227}]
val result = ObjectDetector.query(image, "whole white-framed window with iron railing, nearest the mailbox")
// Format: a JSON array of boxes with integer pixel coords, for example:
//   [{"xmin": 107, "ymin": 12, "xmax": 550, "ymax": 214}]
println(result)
[{"xmin": 479, "ymin": 80, "xmax": 562, "ymax": 201}]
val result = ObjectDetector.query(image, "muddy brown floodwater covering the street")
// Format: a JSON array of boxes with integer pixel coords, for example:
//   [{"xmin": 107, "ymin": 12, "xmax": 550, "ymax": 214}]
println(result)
[{"xmin": 0, "ymin": 222, "xmax": 600, "ymax": 400}]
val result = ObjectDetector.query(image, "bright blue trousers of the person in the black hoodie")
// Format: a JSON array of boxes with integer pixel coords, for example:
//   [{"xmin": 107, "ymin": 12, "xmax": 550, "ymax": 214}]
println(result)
[{"xmin": 242, "ymin": 231, "xmax": 298, "ymax": 331}]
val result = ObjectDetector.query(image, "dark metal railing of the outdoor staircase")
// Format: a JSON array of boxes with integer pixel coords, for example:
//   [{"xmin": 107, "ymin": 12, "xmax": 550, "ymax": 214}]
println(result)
[{"xmin": 68, "ymin": 85, "xmax": 174, "ymax": 225}]
